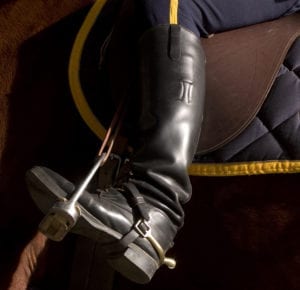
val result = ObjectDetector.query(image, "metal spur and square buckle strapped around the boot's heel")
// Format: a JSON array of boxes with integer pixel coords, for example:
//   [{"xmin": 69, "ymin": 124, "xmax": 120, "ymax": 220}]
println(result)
[{"xmin": 134, "ymin": 219, "xmax": 176, "ymax": 269}]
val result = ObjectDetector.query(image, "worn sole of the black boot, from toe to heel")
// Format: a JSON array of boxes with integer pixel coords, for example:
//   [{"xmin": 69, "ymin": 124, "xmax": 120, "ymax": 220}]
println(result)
[{"xmin": 26, "ymin": 167, "xmax": 159, "ymax": 284}]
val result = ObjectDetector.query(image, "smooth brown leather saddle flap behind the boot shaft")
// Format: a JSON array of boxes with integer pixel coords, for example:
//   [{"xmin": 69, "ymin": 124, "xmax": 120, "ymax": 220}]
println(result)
[{"xmin": 197, "ymin": 13, "xmax": 300, "ymax": 153}]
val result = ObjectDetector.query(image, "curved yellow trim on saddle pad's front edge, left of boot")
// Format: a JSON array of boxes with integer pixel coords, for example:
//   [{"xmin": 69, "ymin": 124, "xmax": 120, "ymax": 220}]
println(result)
[{"xmin": 68, "ymin": 0, "xmax": 107, "ymax": 140}]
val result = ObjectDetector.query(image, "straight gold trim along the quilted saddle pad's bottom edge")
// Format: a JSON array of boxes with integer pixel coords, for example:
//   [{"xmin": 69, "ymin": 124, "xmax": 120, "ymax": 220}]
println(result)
[{"xmin": 189, "ymin": 160, "xmax": 300, "ymax": 176}]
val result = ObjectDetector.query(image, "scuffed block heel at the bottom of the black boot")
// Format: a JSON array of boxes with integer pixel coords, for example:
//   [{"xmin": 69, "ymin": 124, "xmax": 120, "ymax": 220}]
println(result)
[{"xmin": 108, "ymin": 246, "xmax": 159, "ymax": 284}]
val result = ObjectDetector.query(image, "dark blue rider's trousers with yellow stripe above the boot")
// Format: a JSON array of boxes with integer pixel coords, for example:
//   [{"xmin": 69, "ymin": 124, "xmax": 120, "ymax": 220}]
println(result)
[{"xmin": 135, "ymin": 0, "xmax": 300, "ymax": 36}]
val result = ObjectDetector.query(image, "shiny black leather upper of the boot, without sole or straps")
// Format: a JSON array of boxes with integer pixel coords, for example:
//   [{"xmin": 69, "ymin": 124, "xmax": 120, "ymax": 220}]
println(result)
[{"xmin": 85, "ymin": 25, "xmax": 205, "ymax": 262}]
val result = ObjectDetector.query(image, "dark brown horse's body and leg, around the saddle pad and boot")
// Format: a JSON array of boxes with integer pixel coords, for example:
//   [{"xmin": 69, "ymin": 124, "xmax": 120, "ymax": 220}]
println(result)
[{"xmin": 0, "ymin": 0, "xmax": 300, "ymax": 290}]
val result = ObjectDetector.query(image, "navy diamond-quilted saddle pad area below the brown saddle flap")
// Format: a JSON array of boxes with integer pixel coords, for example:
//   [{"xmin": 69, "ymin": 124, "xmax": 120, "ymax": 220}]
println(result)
[{"xmin": 196, "ymin": 34, "xmax": 300, "ymax": 163}]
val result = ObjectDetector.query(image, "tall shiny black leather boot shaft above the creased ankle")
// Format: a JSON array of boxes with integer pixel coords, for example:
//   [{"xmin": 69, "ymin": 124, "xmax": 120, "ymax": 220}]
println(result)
[{"xmin": 133, "ymin": 25, "xmax": 205, "ymax": 202}]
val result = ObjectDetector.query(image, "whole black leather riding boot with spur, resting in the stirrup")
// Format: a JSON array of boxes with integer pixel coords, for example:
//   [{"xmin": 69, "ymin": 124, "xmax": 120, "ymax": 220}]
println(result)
[{"xmin": 27, "ymin": 25, "xmax": 205, "ymax": 283}]
